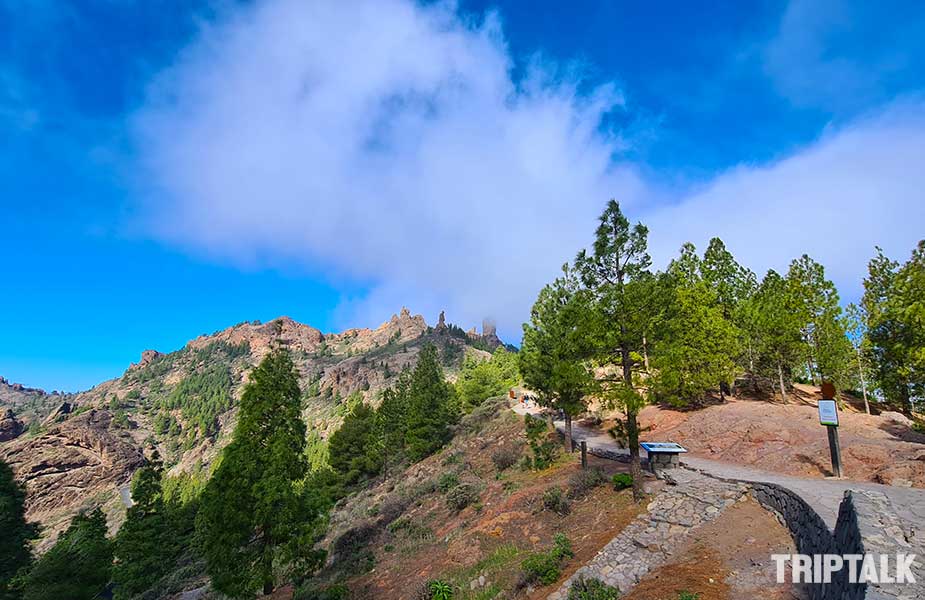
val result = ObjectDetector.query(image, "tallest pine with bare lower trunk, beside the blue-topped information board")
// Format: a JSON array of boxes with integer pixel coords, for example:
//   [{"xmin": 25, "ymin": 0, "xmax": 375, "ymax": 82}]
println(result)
[{"xmin": 575, "ymin": 200, "xmax": 655, "ymax": 500}]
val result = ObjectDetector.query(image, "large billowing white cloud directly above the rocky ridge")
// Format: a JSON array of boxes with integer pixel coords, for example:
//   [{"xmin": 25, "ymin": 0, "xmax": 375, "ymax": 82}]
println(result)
[{"xmin": 136, "ymin": 0, "xmax": 641, "ymax": 334}]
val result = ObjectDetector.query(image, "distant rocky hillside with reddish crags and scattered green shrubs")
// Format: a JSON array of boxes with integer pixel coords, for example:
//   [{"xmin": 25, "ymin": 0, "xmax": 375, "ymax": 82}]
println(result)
[{"xmin": 0, "ymin": 308, "xmax": 501, "ymax": 545}]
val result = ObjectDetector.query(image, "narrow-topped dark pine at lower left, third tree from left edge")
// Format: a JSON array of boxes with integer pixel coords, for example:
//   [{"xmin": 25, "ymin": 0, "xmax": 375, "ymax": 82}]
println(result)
[{"xmin": 112, "ymin": 459, "xmax": 180, "ymax": 599}]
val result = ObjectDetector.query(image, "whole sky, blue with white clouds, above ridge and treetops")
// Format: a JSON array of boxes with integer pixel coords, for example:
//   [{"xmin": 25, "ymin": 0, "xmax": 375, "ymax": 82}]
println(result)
[{"xmin": 0, "ymin": 0, "xmax": 925, "ymax": 390}]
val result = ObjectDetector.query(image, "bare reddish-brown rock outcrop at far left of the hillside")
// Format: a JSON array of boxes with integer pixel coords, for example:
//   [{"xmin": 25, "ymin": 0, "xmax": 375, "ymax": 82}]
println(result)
[{"xmin": 0, "ymin": 410, "xmax": 144, "ymax": 540}]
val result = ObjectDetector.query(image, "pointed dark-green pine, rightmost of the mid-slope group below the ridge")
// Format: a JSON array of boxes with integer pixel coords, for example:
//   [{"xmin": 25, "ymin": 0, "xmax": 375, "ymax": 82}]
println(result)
[{"xmin": 405, "ymin": 344, "xmax": 459, "ymax": 462}]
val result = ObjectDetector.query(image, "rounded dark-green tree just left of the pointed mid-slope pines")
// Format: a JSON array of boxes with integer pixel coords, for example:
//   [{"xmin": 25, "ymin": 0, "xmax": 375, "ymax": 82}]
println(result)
[{"xmin": 328, "ymin": 403, "xmax": 383, "ymax": 486}]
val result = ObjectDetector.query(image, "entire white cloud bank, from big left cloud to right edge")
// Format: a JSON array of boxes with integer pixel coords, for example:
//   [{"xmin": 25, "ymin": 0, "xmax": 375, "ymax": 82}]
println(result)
[{"xmin": 133, "ymin": 0, "xmax": 925, "ymax": 339}]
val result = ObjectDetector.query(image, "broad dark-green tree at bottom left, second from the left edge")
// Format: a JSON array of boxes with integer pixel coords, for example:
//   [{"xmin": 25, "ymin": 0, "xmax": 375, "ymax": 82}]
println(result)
[{"xmin": 23, "ymin": 508, "xmax": 112, "ymax": 600}]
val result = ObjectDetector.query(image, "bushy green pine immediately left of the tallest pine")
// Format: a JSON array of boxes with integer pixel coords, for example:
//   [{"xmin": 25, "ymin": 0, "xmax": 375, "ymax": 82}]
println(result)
[{"xmin": 518, "ymin": 265, "xmax": 594, "ymax": 452}]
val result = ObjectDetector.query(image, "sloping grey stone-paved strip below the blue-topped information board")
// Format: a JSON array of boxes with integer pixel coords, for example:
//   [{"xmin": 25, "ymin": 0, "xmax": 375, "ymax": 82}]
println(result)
[{"xmin": 548, "ymin": 469, "xmax": 748, "ymax": 600}]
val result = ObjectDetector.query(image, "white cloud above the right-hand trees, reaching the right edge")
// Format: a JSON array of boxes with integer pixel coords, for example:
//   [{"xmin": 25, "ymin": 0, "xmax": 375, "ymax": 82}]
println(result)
[{"xmin": 647, "ymin": 102, "xmax": 925, "ymax": 298}]
